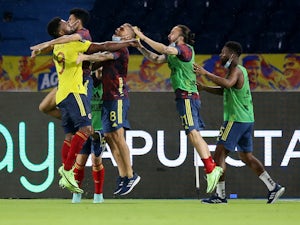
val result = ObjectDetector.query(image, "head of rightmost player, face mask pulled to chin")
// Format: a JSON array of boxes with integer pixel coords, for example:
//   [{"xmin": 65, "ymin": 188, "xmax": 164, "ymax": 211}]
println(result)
[{"xmin": 220, "ymin": 41, "xmax": 243, "ymax": 68}]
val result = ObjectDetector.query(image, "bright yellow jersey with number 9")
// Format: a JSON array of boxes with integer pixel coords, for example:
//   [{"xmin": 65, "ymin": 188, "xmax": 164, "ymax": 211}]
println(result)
[{"xmin": 53, "ymin": 41, "xmax": 91, "ymax": 104}]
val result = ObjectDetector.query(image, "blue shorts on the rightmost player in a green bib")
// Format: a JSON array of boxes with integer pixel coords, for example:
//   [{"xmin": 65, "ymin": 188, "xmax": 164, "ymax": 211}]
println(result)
[{"xmin": 217, "ymin": 121, "xmax": 254, "ymax": 152}]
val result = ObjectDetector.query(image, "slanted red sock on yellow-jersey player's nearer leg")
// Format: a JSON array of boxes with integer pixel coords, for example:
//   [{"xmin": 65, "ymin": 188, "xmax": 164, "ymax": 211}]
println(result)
[{"xmin": 64, "ymin": 131, "xmax": 87, "ymax": 170}]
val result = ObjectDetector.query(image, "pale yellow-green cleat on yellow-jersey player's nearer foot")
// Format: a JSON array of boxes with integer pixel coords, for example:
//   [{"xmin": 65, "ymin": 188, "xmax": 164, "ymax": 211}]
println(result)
[{"xmin": 58, "ymin": 166, "xmax": 83, "ymax": 193}]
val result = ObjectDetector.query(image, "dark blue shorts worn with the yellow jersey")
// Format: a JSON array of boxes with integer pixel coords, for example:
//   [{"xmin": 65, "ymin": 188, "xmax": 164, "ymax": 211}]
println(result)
[{"xmin": 57, "ymin": 93, "xmax": 92, "ymax": 134}]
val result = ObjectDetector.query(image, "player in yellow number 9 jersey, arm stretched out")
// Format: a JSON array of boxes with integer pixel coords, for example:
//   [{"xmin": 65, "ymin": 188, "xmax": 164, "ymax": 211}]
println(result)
[{"xmin": 48, "ymin": 17, "xmax": 138, "ymax": 193}]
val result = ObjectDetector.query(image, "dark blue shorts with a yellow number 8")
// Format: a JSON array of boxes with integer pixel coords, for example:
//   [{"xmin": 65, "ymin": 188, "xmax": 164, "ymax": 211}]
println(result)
[{"xmin": 102, "ymin": 98, "xmax": 130, "ymax": 133}]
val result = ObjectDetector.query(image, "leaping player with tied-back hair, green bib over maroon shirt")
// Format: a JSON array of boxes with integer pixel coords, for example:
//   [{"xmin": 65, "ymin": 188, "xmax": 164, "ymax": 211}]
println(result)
[{"xmin": 133, "ymin": 25, "xmax": 223, "ymax": 193}]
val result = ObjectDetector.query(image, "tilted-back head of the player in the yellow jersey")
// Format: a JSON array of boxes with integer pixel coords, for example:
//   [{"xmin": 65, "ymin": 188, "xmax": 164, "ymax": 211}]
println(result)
[{"xmin": 47, "ymin": 17, "xmax": 72, "ymax": 38}]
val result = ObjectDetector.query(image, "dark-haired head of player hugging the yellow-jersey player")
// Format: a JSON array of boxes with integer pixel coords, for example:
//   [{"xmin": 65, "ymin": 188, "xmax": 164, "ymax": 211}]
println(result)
[{"xmin": 68, "ymin": 8, "xmax": 90, "ymax": 31}]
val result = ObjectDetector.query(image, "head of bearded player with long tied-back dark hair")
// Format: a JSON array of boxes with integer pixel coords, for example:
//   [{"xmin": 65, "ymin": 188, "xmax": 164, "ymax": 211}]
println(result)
[{"xmin": 168, "ymin": 24, "xmax": 195, "ymax": 45}]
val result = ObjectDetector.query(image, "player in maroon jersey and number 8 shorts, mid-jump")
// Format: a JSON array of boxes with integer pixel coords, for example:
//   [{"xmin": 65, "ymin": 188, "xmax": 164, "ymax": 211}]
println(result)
[{"xmin": 77, "ymin": 23, "xmax": 141, "ymax": 195}]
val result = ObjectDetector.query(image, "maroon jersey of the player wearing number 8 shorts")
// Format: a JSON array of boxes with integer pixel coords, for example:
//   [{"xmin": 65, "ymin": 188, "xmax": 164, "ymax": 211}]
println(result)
[{"xmin": 102, "ymin": 48, "xmax": 129, "ymax": 100}]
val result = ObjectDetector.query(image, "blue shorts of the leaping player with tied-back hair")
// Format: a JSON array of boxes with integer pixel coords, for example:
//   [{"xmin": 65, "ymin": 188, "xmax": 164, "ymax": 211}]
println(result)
[{"xmin": 176, "ymin": 97, "xmax": 205, "ymax": 134}]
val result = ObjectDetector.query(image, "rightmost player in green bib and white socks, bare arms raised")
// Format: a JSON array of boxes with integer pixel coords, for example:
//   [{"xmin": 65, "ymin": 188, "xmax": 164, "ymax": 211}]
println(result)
[{"xmin": 194, "ymin": 41, "xmax": 285, "ymax": 203}]
